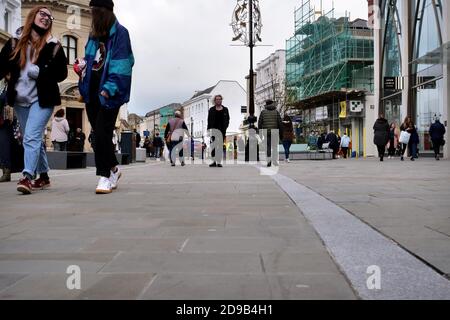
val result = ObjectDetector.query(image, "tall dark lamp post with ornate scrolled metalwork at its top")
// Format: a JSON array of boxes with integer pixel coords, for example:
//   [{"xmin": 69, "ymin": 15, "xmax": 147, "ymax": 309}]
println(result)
[{"xmin": 231, "ymin": 0, "xmax": 262, "ymax": 161}]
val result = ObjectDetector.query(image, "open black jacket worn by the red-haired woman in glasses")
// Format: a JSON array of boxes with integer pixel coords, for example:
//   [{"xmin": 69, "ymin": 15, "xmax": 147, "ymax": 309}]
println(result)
[{"xmin": 0, "ymin": 35, "xmax": 67, "ymax": 108}]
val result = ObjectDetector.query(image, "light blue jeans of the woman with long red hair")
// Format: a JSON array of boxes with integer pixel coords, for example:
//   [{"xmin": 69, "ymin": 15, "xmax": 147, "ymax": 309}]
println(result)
[{"xmin": 14, "ymin": 102, "xmax": 53, "ymax": 177}]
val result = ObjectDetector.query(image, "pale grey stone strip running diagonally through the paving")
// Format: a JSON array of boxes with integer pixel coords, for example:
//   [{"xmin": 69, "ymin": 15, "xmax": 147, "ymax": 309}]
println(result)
[{"xmin": 271, "ymin": 174, "xmax": 450, "ymax": 300}]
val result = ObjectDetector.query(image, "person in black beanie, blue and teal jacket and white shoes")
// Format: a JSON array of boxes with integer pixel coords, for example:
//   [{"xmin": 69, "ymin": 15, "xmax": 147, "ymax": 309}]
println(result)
[{"xmin": 76, "ymin": 0, "xmax": 134, "ymax": 194}]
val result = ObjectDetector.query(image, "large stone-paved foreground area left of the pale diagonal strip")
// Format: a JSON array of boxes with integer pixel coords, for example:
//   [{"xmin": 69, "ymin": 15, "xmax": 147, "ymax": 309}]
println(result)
[{"xmin": 0, "ymin": 162, "xmax": 358, "ymax": 300}]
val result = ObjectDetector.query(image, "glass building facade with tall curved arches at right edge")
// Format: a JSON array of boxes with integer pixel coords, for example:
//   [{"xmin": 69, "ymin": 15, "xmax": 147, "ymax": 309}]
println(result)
[{"xmin": 376, "ymin": 0, "xmax": 450, "ymax": 153}]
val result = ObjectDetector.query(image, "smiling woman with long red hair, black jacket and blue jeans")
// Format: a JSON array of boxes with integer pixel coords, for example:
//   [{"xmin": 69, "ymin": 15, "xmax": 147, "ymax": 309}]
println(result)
[{"xmin": 0, "ymin": 6, "xmax": 67, "ymax": 194}]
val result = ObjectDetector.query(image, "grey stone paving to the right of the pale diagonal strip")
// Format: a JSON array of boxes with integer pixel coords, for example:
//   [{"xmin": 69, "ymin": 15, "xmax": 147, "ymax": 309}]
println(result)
[{"xmin": 280, "ymin": 158, "xmax": 450, "ymax": 275}]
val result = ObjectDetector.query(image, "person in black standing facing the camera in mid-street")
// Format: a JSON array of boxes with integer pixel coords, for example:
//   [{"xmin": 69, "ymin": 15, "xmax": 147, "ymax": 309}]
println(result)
[{"xmin": 208, "ymin": 95, "xmax": 230, "ymax": 168}]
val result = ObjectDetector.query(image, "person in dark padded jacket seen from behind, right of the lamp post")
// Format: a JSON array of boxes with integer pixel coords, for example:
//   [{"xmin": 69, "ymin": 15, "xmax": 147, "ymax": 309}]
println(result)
[{"xmin": 258, "ymin": 100, "xmax": 283, "ymax": 167}]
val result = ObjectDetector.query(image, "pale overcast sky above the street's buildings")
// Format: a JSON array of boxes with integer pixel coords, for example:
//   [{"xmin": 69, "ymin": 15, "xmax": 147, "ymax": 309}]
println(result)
[{"xmin": 114, "ymin": 0, "xmax": 367, "ymax": 115}]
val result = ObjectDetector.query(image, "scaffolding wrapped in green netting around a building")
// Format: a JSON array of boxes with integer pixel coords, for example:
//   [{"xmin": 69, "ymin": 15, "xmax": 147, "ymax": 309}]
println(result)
[{"xmin": 286, "ymin": 0, "xmax": 374, "ymax": 105}]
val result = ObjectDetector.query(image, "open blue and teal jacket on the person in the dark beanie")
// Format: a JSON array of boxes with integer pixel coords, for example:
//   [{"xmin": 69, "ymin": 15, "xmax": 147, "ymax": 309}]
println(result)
[{"xmin": 79, "ymin": 21, "xmax": 134, "ymax": 109}]
